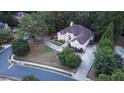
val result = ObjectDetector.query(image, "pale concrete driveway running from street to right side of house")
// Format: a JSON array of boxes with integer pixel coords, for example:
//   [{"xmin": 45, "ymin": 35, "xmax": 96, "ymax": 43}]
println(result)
[{"xmin": 73, "ymin": 46, "xmax": 96, "ymax": 80}]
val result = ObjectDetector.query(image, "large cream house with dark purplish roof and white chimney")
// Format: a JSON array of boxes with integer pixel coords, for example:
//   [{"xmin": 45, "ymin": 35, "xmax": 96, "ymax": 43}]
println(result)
[{"xmin": 57, "ymin": 22, "xmax": 94, "ymax": 50}]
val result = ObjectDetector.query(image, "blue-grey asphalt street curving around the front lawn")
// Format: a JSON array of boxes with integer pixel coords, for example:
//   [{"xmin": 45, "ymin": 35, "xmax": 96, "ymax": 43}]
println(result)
[{"xmin": 0, "ymin": 47, "xmax": 75, "ymax": 81}]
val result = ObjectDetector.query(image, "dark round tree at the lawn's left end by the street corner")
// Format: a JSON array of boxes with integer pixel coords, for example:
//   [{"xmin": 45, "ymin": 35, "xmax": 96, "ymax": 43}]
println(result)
[{"xmin": 12, "ymin": 39, "xmax": 30, "ymax": 56}]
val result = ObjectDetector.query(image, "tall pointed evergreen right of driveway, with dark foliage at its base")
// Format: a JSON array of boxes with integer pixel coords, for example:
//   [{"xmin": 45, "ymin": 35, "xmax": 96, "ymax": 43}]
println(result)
[{"xmin": 95, "ymin": 23, "xmax": 122, "ymax": 76}]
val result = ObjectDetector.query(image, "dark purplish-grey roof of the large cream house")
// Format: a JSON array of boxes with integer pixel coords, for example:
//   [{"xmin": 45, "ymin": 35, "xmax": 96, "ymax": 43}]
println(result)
[{"xmin": 60, "ymin": 25, "xmax": 94, "ymax": 45}]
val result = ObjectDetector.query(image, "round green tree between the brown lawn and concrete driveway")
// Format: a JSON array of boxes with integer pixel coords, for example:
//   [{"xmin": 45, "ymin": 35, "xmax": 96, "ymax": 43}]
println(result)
[{"xmin": 58, "ymin": 47, "xmax": 81, "ymax": 68}]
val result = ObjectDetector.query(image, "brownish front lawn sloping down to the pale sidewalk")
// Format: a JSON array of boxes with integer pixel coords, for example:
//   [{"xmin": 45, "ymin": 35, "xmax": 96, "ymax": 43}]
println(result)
[{"xmin": 15, "ymin": 45, "xmax": 77, "ymax": 73}]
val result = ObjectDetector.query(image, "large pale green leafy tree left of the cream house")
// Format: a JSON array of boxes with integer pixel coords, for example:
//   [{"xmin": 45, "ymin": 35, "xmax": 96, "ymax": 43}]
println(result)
[{"xmin": 19, "ymin": 13, "xmax": 48, "ymax": 40}]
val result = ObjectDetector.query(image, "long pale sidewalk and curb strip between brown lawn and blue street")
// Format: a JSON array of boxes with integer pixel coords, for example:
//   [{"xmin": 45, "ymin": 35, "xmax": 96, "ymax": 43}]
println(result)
[{"xmin": 8, "ymin": 55, "xmax": 75, "ymax": 76}]
